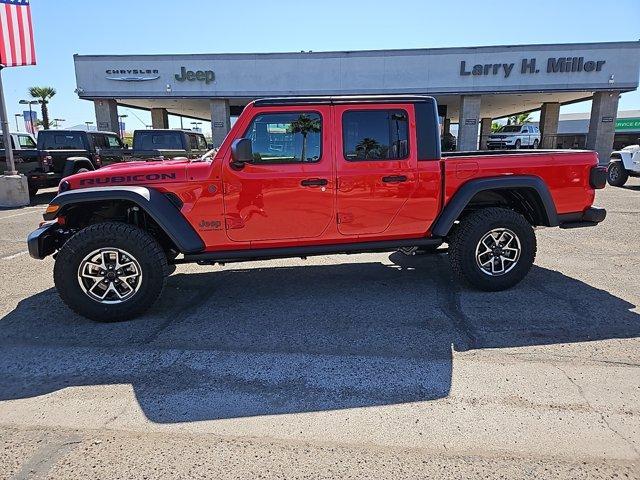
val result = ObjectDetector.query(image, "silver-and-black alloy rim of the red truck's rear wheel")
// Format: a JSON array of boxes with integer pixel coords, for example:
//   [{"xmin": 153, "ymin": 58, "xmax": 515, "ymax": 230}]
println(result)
[{"xmin": 476, "ymin": 228, "xmax": 522, "ymax": 277}]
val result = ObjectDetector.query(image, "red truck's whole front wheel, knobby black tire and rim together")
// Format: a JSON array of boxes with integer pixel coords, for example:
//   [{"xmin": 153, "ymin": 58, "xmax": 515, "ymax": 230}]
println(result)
[{"xmin": 53, "ymin": 222, "xmax": 168, "ymax": 322}]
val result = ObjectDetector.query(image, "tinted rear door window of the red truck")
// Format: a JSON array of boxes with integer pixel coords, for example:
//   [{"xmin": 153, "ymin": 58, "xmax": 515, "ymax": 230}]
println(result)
[{"xmin": 342, "ymin": 110, "xmax": 409, "ymax": 161}]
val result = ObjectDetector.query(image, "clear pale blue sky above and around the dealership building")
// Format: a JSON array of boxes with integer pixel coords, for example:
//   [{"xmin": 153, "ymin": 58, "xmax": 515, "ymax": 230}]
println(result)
[{"xmin": 3, "ymin": 0, "xmax": 640, "ymax": 130}]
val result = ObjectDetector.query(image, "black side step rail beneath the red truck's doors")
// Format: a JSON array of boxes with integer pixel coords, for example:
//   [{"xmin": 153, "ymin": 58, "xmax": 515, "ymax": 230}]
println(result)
[{"xmin": 178, "ymin": 238, "xmax": 442, "ymax": 265}]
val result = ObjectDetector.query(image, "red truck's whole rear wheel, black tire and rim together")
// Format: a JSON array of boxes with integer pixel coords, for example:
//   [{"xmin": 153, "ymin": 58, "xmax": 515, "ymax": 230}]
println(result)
[{"xmin": 449, "ymin": 208, "xmax": 537, "ymax": 291}]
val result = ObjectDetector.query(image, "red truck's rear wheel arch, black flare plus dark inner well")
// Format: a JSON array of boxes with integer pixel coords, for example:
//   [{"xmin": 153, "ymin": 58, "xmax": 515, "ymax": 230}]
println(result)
[{"xmin": 431, "ymin": 176, "xmax": 560, "ymax": 237}]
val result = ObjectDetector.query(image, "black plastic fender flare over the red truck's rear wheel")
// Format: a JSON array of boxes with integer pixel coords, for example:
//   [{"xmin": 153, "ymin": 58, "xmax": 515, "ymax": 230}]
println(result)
[{"xmin": 431, "ymin": 175, "xmax": 560, "ymax": 237}]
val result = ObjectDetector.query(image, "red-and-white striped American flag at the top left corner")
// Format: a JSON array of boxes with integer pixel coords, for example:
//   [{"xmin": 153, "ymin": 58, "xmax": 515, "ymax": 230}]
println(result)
[{"xmin": 0, "ymin": 0, "xmax": 36, "ymax": 67}]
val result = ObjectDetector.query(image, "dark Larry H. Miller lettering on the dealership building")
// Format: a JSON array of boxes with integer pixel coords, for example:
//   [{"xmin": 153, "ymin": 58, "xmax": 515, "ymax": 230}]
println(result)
[{"xmin": 460, "ymin": 57, "xmax": 606, "ymax": 78}]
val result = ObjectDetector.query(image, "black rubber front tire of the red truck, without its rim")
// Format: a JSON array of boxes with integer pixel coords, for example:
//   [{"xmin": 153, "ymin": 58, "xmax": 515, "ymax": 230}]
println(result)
[{"xmin": 53, "ymin": 222, "xmax": 169, "ymax": 322}]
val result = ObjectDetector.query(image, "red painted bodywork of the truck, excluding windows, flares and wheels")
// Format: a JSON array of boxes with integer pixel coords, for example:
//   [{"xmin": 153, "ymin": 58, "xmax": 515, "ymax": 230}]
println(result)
[{"xmin": 61, "ymin": 103, "xmax": 598, "ymax": 251}]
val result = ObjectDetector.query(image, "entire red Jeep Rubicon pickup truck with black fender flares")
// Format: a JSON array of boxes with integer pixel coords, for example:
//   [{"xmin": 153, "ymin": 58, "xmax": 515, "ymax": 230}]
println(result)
[{"xmin": 28, "ymin": 96, "xmax": 606, "ymax": 321}]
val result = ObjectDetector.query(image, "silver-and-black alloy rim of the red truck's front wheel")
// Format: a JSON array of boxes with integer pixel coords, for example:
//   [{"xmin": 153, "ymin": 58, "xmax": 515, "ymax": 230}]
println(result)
[{"xmin": 78, "ymin": 248, "xmax": 142, "ymax": 304}]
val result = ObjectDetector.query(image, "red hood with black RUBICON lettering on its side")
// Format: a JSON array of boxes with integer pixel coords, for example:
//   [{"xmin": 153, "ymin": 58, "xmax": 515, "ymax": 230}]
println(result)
[{"xmin": 64, "ymin": 159, "xmax": 189, "ymax": 190}]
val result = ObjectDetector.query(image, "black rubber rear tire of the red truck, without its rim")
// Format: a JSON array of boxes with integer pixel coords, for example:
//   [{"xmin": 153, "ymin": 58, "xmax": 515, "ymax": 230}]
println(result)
[{"xmin": 448, "ymin": 207, "xmax": 537, "ymax": 291}]
